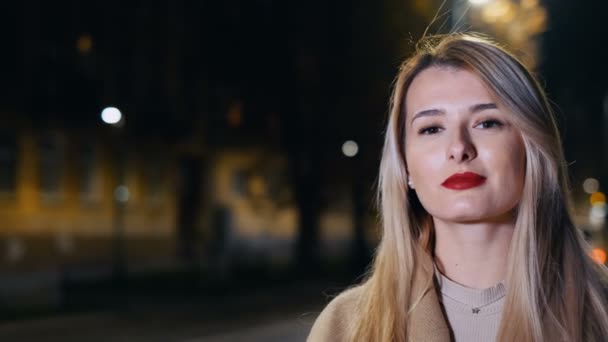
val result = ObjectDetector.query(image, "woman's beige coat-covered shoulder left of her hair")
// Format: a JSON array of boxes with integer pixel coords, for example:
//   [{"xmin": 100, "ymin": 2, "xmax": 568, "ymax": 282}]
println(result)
[{"xmin": 306, "ymin": 285, "xmax": 363, "ymax": 342}]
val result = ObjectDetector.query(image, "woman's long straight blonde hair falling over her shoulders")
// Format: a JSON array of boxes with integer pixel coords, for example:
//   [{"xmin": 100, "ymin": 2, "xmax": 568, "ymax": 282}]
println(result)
[{"xmin": 350, "ymin": 33, "xmax": 608, "ymax": 342}]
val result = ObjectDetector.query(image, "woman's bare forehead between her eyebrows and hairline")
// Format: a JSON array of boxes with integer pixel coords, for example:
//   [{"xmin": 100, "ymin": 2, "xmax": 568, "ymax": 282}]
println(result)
[{"xmin": 405, "ymin": 67, "xmax": 496, "ymax": 117}]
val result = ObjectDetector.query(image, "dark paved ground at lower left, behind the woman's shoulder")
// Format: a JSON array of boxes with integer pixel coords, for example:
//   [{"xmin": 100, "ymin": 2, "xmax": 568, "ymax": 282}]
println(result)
[{"xmin": 0, "ymin": 280, "xmax": 347, "ymax": 342}]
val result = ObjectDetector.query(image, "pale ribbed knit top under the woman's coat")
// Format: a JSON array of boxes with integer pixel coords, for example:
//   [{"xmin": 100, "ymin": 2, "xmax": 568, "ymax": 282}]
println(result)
[{"xmin": 436, "ymin": 272, "xmax": 506, "ymax": 342}]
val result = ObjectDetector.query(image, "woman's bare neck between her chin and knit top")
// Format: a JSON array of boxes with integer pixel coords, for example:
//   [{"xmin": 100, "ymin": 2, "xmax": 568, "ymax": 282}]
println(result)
[{"xmin": 433, "ymin": 218, "xmax": 515, "ymax": 289}]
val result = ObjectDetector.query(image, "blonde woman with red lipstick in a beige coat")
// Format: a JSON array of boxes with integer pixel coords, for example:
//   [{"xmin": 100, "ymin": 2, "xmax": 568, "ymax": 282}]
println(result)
[{"xmin": 309, "ymin": 34, "xmax": 608, "ymax": 342}]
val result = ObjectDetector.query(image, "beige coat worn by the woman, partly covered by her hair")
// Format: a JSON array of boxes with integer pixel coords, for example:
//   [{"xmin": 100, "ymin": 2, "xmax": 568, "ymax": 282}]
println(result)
[{"xmin": 307, "ymin": 280, "xmax": 451, "ymax": 342}]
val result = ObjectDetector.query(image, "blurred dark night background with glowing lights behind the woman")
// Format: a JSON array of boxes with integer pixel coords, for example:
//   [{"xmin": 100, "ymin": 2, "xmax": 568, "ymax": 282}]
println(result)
[{"xmin": 0, "ymin": 0, "xmax": 608, "ymax": 341}]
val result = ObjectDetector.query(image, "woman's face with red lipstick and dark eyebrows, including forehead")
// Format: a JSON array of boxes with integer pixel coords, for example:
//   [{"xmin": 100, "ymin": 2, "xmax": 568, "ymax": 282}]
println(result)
[{"xmin": 405, "ymin": 67, "xmax": 525, "ymax": 223}]
